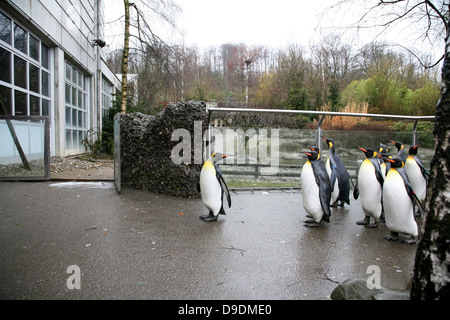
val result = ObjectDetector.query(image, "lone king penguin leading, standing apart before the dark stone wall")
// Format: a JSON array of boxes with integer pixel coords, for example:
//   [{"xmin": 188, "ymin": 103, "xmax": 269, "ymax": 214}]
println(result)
[{"xmin": 198, "ymin": 152, "xmax": 231, "ymax": 222}]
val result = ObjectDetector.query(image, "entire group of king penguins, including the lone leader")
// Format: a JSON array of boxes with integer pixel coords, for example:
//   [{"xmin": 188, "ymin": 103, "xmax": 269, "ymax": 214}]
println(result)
[{"xmin": 198, "ymin": 136, "xmax": 429, "ymax": 244}]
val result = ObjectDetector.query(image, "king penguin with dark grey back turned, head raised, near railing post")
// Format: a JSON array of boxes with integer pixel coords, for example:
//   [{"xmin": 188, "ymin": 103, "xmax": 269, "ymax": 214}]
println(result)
[{"xmin": 322, "ymin": 136, "xmax": 350, "ymax": 206}]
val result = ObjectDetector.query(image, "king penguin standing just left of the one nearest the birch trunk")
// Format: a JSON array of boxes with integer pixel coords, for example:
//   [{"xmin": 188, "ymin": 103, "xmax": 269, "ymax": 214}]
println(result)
[{"xmin": 353, "ymin": 146, "xmax": 384, "ymax": 228}]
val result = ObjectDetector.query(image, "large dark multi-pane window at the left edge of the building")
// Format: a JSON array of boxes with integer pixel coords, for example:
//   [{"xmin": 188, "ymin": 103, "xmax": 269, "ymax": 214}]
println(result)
[{"xmin": 0, "ymin": 11, "xmax": 52, "ymax": 115}]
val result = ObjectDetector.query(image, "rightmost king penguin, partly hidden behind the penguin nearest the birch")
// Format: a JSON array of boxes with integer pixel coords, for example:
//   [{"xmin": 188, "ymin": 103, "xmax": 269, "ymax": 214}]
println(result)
[{"xmin": 405, "ymin": 145, "xmax": 430, "ymax": 211}]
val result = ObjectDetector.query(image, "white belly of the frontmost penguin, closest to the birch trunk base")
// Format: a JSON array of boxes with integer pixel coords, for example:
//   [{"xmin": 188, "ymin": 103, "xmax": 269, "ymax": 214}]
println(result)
[{"xmin": 383, "ymin": 169, "xmax": 418, "ymax": 236}]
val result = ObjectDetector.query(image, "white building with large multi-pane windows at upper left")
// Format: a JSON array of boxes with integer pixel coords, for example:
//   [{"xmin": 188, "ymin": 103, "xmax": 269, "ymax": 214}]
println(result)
[{"xmin": 0, "ymin": 0, "xmax": 120, "ymax": 156}]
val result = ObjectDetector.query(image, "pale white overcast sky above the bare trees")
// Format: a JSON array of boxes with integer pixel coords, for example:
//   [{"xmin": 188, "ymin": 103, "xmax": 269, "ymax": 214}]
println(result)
[{"xmin": 104, "ymin": 0, "xmax": 443, "ymax": 60}]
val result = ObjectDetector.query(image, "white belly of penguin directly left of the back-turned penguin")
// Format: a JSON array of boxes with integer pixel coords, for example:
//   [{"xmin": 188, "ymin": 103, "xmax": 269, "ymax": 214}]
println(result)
[{"xmin": 300, "ymin": 162, "xmax": 323, "ymax": 223}]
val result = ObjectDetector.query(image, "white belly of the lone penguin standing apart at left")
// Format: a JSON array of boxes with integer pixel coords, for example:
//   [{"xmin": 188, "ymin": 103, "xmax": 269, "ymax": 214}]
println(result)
[{"xmin": 200, "ymin": 163, "xmax": 222, "ymax": 216}]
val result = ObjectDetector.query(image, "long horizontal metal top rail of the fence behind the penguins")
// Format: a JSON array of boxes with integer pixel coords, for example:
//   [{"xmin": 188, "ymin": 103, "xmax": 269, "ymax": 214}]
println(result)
[{"xmin": 208, "ymin": 108, "xmax": 435, "ymax": 121}]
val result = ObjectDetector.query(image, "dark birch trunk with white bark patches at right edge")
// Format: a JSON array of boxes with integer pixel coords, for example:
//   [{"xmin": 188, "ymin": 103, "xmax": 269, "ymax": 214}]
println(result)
[{"xmin": 411, "ymin": 21, "xmax": 450, "ymax": 300}]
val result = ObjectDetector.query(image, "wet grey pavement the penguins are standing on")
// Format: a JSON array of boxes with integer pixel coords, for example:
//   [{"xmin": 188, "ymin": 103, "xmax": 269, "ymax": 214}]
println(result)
[{"xmin": 0, "ymin": 181, "xmax": 422, "ymax": 300}]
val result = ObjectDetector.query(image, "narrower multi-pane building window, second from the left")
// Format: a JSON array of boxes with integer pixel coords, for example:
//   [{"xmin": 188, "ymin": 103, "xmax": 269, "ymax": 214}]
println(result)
[{"xmin": 65, "ymin": 62, "xmax": 89, "ymax": 149}]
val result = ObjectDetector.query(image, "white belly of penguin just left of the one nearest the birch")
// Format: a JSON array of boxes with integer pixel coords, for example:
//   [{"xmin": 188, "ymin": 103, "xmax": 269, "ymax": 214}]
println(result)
[{"xmin": 358, "ymin": 160, "xmax": 382, "ymax": 220}]
